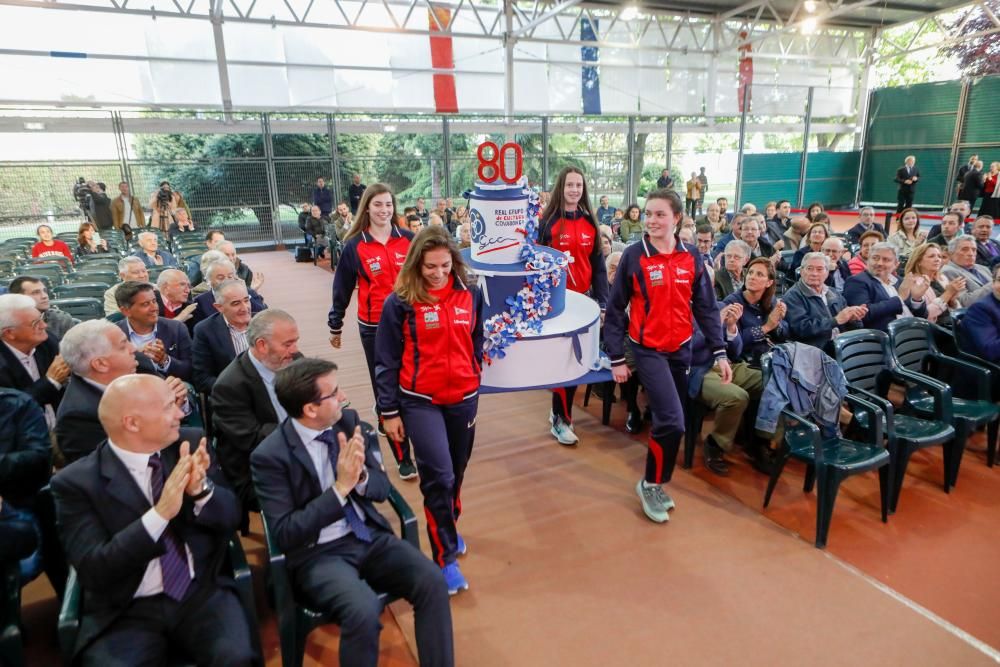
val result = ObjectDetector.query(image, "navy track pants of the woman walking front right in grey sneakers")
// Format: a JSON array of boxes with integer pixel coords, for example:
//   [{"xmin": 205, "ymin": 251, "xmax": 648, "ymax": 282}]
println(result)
[{"xmin": 627, "ymin": 341, "xmax": 691, "ymax": 484}]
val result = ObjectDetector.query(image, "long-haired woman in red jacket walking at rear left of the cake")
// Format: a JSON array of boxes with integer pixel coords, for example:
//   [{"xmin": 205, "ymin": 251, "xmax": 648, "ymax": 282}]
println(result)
[{"xmin": 328, "ymin": 183, "xmax": 417, "ymax": 479}]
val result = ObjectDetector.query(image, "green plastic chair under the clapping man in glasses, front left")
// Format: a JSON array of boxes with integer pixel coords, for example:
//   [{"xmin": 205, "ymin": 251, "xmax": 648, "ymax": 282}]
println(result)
[{"xmin": 261, "ymin": 423, "xmax": 420, "ymax": 667}]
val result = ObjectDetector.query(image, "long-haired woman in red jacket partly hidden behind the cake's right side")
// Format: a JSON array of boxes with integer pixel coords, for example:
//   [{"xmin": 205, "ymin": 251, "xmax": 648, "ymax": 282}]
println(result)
[{"xmin": 538, "ymin": 167, "xmax": 608, "ymax": 445}]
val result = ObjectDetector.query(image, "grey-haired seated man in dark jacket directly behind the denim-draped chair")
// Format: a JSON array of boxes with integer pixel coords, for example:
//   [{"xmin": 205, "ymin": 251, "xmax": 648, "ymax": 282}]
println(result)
[{"xmin": 781, "ymin": 253, "xmax": 868, "ymax": 352}]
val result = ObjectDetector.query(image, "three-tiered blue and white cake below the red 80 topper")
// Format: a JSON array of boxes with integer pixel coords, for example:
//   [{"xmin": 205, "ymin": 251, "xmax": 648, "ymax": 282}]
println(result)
[{"xmin": 463, "ymin": 179, "xmax": 601, "ymax": 389}]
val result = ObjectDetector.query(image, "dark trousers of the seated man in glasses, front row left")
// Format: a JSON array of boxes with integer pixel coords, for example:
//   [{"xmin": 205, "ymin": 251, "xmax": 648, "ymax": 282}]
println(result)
[{"xmin": 293, "ymin": 524, "xmax": 455, "ymax": 667}]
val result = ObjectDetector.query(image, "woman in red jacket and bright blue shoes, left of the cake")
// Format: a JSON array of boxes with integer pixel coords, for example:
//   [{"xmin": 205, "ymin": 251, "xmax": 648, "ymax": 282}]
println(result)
[{"xmin": 375, "ymin": 226, "xmax": 483, "ymax": 595}]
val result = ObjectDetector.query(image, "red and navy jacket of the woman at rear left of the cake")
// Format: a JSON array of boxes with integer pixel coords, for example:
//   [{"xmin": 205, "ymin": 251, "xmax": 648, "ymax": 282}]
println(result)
[{"xmin": 327, "ymin": 225, "xmax": 413, "ymax": 334}]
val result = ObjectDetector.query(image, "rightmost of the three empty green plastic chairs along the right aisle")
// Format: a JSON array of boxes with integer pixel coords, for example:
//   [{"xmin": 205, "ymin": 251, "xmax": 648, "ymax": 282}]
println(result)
[{"xmin": 889, "ymin": 317, "xmax": 1000, "ymax": 491}]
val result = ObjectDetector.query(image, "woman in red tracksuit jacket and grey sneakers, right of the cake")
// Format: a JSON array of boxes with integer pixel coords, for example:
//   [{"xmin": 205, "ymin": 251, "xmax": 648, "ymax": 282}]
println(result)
[{"xmin": 604, "ymin": 190, "xmax": 732, "ymax": 523}]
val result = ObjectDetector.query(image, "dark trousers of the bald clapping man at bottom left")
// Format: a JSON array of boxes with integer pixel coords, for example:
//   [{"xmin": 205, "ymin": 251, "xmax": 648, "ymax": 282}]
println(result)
[{"xmin": 80, "ymin": 585, "xmax": 257, "ymax": 667}]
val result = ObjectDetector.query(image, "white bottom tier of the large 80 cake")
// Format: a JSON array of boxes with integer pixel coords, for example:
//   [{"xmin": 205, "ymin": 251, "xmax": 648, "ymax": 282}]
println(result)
[{"xmin": 482, "ymin": 292, "xmax": 601, "ymax": 389}]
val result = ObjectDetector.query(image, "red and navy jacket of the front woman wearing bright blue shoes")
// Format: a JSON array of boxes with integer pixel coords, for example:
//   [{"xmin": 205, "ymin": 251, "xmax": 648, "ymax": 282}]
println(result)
[{"xmin": 375, "ymin": 276, "xmax": 483, "ymax": 417}]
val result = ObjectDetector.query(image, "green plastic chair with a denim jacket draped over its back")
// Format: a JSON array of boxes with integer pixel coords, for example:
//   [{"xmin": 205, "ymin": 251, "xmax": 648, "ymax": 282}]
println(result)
[{"xmin": 761, "ymin": 352, "xmax": 893, "ymax": 549}]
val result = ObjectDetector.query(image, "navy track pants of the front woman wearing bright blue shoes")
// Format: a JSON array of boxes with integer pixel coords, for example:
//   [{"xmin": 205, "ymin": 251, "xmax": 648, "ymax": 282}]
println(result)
[{"xmin": 399, "ymin": 394, "xmax": 479, "ymax": 567}]
